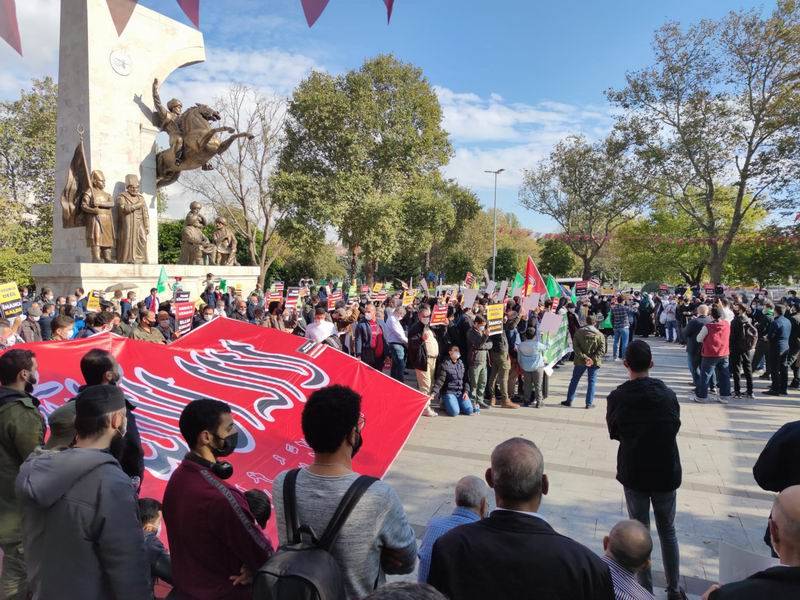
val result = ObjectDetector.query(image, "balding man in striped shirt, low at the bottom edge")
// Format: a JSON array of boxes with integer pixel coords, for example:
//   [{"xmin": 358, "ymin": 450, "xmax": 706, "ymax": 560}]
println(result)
[{"xmin": 603, "ymin": 519, "xmax": 653, "ymax": 600}]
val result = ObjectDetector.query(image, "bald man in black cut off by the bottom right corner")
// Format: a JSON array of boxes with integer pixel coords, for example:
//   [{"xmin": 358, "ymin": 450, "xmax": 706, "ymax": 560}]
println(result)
[{"xmin": 703, "ymin": 485, "xmax": 800, "ymax": 600}]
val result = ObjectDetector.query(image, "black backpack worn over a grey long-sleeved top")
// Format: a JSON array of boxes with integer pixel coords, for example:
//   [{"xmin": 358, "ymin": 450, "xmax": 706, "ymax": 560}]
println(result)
[{"xmin": 253, "ymin": 469, "xmax": 377, "ymax": 600}]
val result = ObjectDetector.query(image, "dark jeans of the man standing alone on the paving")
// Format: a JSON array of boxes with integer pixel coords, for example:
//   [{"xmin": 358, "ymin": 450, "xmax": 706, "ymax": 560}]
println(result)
[{"xmin": 625, "ymin": 488, "xmax": 680, "ymax": 592}]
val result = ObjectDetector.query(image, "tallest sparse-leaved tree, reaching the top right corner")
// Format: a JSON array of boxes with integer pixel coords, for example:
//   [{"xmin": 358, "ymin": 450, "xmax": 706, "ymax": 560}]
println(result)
[{"xmin": 608, "ymin": 0, "xmax": 800, "ymax": 283}]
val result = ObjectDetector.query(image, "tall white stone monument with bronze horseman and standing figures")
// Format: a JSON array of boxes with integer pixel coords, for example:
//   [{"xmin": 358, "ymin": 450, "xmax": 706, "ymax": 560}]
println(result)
[{"xmin": 33, "ymin": 0, "xmax": 258, "ymax": 297}]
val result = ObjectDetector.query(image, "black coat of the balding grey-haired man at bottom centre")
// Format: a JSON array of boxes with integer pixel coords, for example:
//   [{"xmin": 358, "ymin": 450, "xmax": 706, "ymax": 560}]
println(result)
[{"xmin": 428, "ymin": 510, "xmax": 614, "ymax": 600}]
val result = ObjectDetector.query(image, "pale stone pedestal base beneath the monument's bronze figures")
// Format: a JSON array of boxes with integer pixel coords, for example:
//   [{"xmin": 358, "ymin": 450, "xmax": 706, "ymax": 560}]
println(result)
[{"xmin": 33, "ymin": 263, "xmax": 259, "ymax": 301}]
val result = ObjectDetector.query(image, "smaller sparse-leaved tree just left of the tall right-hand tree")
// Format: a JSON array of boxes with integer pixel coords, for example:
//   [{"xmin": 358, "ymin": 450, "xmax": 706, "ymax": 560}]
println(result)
[{"xmin": 519, "ymin": 136, "xmax": 648, "ymax": 279}]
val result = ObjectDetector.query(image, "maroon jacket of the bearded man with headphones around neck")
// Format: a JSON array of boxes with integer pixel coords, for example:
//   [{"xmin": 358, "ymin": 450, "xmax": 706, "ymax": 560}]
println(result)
[{"xmin": 163, "ymin": 458, "xmax": 272, "ymax": 600}]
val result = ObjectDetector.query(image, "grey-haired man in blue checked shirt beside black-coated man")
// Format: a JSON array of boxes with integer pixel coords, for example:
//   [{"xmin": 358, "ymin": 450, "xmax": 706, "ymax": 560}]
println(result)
[{"xmin": 417, "ymin": 475, "xmax": 489, "ymax": 583}]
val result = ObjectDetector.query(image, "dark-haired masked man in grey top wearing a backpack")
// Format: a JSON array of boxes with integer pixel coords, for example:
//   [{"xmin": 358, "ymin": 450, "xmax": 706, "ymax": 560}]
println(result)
[{"xmin": 272, "ymin": 385, "xmax": 417, "ymax": 600}]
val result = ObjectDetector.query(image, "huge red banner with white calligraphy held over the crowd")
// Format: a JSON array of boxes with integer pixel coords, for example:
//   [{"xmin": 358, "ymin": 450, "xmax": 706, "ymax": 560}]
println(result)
[{"xmin": 10, "ymin": 318, "xmax": 425, "ymax": 539}]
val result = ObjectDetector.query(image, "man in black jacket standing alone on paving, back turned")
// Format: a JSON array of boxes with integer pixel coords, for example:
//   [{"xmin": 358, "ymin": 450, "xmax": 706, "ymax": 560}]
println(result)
[{"xmin": 606, "ymin": 338, "xmax": 688, "ymax": 600}]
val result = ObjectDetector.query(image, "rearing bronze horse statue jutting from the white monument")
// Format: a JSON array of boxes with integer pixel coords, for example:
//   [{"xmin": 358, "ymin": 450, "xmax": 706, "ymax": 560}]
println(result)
[{"xmin": 156, "ymin": 104, "xmax": 253, "ymax": 187}]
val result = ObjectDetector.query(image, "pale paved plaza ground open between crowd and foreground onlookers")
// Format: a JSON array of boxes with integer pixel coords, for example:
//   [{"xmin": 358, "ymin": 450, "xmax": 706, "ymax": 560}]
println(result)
[{"xmin": 386, "ymin": 338, "xmax": 800, "ymax": 597}]
